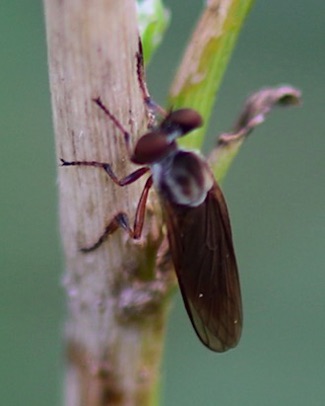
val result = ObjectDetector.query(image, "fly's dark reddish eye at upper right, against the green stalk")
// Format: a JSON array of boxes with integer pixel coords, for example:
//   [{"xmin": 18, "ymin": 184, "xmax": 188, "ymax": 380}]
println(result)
[{"xmin": 160, "ymin": 109, "xmax": 203, "ymax": 136}]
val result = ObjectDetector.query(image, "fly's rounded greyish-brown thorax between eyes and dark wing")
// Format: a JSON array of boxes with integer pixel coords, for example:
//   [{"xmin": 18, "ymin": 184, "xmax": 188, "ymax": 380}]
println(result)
[{"xmin": 151, "ymin": 150, "xmax": 213, "ymax": 207}]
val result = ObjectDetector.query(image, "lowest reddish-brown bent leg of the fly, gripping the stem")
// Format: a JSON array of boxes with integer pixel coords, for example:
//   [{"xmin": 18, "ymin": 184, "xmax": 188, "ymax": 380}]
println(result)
[{"xmin": 81, "ymin": 176, "xmax": 153, "ymax": 253}]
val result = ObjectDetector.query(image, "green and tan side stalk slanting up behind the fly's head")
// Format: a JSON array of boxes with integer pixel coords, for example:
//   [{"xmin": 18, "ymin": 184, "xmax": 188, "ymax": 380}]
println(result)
[{"xmin": 168, "ymin": 0, "xmax": 254, "ymax": 149}]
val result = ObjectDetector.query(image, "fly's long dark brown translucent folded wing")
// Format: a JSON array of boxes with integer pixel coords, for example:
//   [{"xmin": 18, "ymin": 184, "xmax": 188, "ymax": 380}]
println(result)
[{"xmin": 162, "ymin": 183, "xmax": 242, "ymax": 352}]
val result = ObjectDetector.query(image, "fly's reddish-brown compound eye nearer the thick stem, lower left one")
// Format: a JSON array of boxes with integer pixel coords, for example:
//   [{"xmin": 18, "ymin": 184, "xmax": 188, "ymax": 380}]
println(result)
[{"xmin": 131, "ymin": 131, "xmax": 176, "ymax": 165}]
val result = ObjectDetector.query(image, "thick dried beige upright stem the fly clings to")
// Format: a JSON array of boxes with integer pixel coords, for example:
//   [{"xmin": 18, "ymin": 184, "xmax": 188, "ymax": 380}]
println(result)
[{"xmin": 44, "ymin": 0, "xmax": 170, "ymax": 406}]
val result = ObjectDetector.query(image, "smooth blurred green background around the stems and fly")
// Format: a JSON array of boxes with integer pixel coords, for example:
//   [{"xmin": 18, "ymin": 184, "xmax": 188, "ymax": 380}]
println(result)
[{"xmin": 0, "ymin": 0, "xmax": 325, "ymax": 406}]
